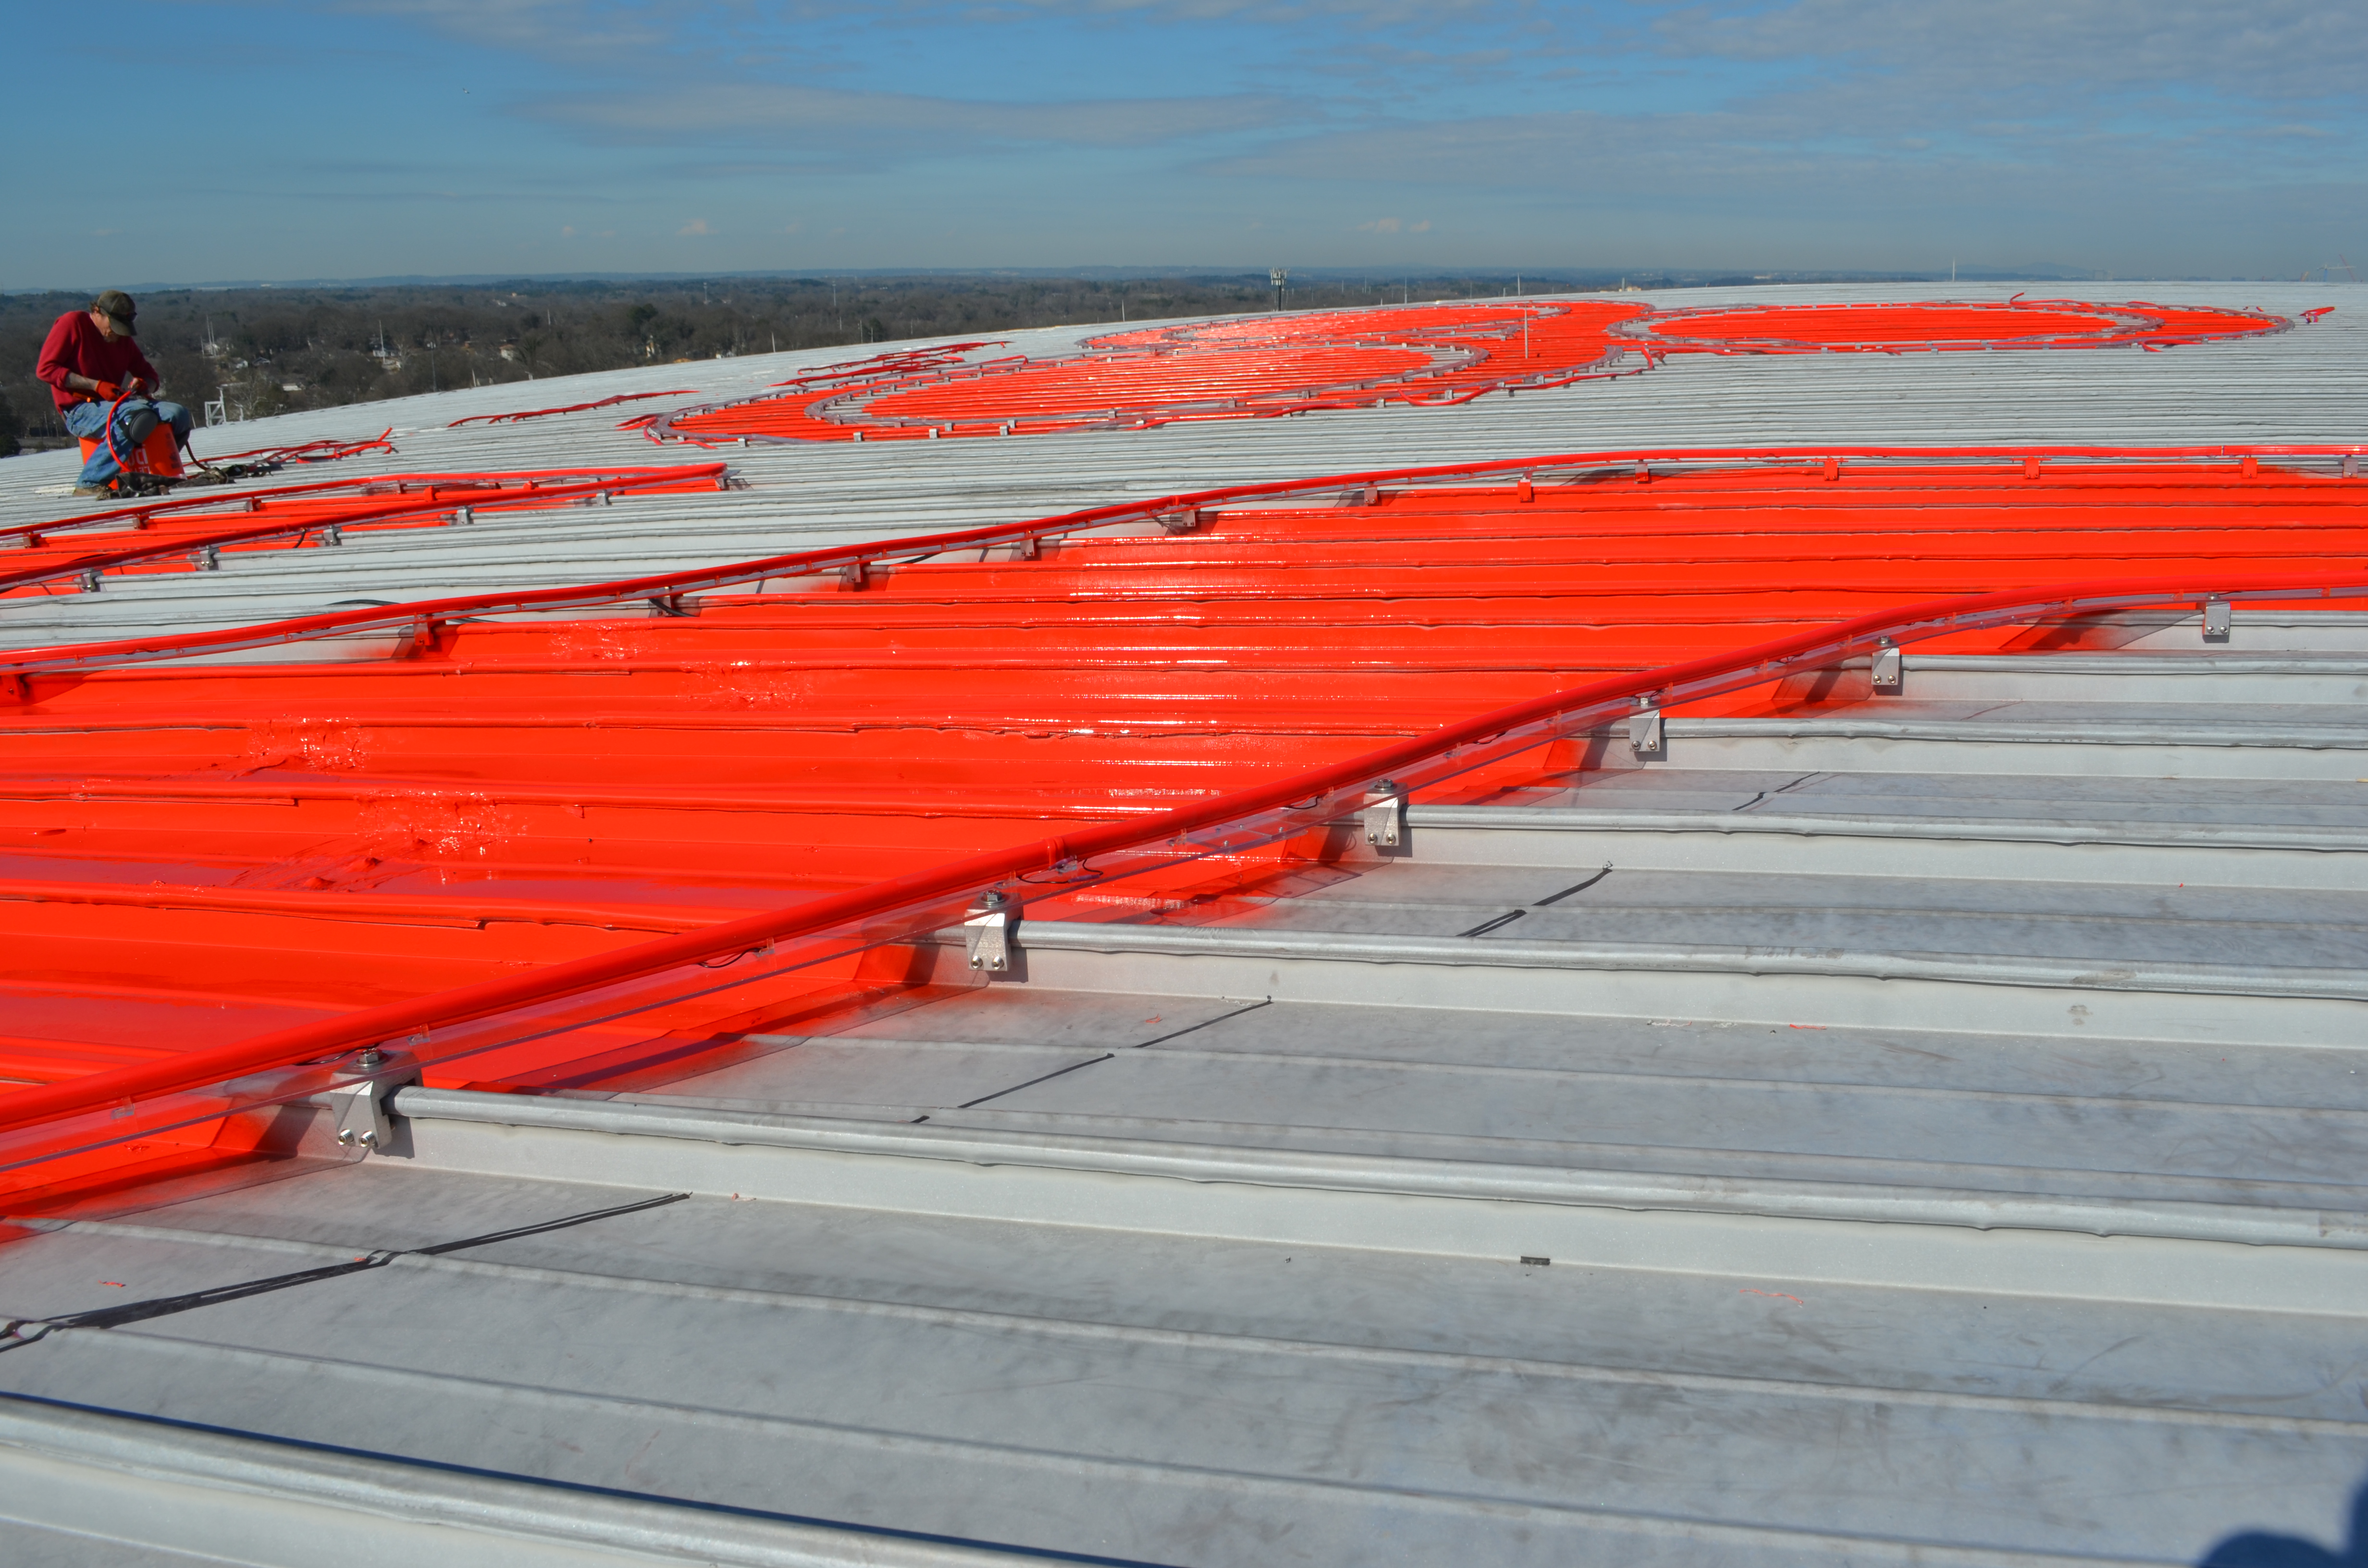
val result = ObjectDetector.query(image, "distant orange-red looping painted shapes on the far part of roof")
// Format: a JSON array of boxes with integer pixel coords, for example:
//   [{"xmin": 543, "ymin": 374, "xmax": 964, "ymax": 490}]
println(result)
[{"xmin": 649, "ymin": 301, "xmax": 2292, "ymax": 443}]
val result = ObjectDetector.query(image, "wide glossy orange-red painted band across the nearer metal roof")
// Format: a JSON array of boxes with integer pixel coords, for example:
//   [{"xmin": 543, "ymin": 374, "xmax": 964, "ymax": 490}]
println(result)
[{"xmin": 0, "ymin": 455, "xmax": 2368, "ymax": 1208}]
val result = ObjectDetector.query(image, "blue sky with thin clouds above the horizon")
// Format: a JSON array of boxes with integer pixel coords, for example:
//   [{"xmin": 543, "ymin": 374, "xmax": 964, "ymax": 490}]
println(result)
[{"xmin": 0, "ymin": 0, "xmax": 2368, "ymax": 289}]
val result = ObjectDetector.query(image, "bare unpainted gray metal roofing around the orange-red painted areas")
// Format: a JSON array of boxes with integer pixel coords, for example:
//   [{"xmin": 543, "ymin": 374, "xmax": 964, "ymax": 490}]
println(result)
[{"xmin": 0, "ymin": 287, "xmax": 2368, "ymax": 1568}]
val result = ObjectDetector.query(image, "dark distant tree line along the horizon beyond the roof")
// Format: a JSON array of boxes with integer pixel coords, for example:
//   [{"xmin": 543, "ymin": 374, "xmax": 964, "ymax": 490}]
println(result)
[{"xmin": 0, "ymin": 272, "xmax": 1923, "ymax": 455}]
